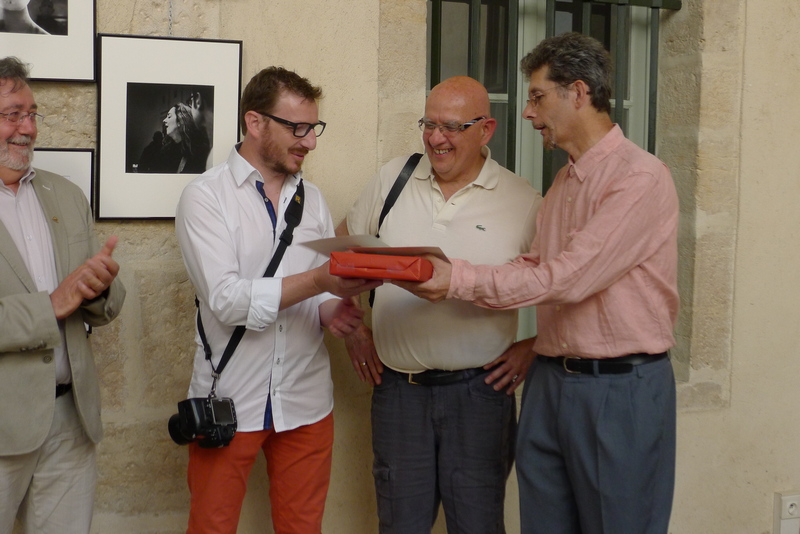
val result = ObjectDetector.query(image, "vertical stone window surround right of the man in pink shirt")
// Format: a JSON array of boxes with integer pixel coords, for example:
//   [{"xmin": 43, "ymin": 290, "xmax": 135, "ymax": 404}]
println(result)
[{"xmin": 658, "ymin": 1, "xmax": 744, "ymax": 410}]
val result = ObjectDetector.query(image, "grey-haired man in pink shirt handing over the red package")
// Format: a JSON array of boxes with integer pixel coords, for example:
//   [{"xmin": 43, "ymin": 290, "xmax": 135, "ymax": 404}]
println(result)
[{"xmin": 401, "ymin": 33, "xmax": 678, "ymax": 534}]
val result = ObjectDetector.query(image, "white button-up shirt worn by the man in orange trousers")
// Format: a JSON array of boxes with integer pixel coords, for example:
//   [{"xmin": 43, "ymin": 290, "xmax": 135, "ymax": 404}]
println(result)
[{"xmin": 175, "ymin": 148, "xmax": 335, "ymax": 432}]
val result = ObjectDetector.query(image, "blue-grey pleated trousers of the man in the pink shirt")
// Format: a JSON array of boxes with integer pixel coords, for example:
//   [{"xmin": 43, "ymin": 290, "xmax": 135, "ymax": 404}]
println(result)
[{"xmin": 517, "ymin": 359, "xmax": 675, "ymax": 534}]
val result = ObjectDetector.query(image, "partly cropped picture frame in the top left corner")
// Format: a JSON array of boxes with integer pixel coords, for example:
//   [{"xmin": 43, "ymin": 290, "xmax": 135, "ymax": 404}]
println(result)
[{"xmin": 0, "ymin": 0, "xmax": 96, "ymax": 82}]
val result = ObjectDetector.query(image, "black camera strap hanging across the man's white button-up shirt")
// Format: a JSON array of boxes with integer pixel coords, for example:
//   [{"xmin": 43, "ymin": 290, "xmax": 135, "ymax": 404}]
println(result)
[{"xmin": 194, "ymin": 178, "xmax": 305, "ymax": 397}]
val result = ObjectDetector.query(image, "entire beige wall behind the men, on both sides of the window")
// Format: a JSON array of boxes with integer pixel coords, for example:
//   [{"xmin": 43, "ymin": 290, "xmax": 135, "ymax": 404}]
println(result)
[{"xmin": 14, "ymin": 0, "xmax": 800, "ymax": 534}]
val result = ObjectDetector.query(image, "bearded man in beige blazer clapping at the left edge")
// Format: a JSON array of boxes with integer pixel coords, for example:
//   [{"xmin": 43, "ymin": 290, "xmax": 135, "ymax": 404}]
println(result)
[{"xmin": 0, "ymin": 57, "xmax": 125, "ymax": 534}]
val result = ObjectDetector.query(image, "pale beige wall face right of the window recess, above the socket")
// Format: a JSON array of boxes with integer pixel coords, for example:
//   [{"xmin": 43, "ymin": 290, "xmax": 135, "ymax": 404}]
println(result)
[{"xmin": 671, "ymin": 0, "xmax": 800, "ymax": 534}]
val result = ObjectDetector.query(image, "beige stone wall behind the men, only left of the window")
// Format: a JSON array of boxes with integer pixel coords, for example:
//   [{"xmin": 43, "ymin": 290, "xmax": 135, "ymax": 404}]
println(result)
[{"xmin": 12, "ymin": 0, "xmax": 432, "ymax": 534}]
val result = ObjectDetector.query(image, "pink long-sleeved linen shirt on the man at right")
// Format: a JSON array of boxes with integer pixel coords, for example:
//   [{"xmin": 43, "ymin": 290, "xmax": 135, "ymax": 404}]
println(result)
[{"xmin": 447, "ymin": 125, "xmax": 679, "ymax": 358}]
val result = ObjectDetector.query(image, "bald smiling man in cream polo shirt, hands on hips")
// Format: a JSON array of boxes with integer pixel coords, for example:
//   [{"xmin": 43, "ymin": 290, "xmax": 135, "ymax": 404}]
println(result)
[{"xmin": 337, "ymin": 76, "xmax": 541, "ymax": 534}]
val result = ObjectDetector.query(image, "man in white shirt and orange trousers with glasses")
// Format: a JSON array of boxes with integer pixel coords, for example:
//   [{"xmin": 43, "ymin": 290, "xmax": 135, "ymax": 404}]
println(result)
[{"xmin": 175, "ymin": 67, "xmax": 380, "ymax": 534}]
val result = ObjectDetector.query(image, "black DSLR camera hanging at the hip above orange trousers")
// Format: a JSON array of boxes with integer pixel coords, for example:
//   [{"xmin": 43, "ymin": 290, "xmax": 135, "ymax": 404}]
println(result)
[{"xmin": 169, "ymin": 396, "xmax": 236, "ymax": 449}]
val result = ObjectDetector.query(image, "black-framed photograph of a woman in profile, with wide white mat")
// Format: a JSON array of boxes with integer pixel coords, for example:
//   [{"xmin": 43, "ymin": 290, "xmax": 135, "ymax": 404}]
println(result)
[{"xmin": 96, "ymin": 34, "xmax": 242, "ymax": 219}]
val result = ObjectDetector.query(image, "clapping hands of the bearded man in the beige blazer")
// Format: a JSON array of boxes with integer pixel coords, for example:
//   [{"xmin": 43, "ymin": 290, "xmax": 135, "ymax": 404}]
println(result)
[{"xmin": 50, "ymin": 236, "xmax": 119, "ymax": 320}]
